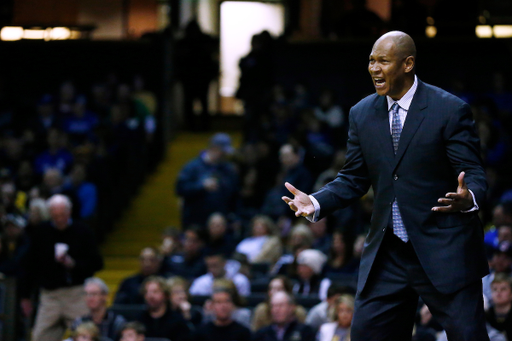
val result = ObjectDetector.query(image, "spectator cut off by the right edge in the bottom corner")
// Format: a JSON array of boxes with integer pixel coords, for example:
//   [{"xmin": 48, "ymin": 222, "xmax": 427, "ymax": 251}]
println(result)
[{"xmin": 486, "ymin": 273, "xmax": 512, "ymax": 337}]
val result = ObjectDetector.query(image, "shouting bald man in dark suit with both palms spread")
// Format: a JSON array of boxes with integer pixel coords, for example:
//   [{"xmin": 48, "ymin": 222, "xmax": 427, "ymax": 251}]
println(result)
[{"xmin": 283, "ymin": 31, "xmax": 488, "ymax": 341}]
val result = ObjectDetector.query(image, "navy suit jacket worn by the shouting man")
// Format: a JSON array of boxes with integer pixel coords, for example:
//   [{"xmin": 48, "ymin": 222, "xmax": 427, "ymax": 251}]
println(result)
[{"xmin": 313, "ymin": 80, "xmax": 489, "ymax": 293}]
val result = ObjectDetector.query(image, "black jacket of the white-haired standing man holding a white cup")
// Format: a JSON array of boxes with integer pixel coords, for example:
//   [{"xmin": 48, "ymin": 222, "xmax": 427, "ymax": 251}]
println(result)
[{"xmin": 20, "ymin": 221, "xmax": 103, "ymax": 297}]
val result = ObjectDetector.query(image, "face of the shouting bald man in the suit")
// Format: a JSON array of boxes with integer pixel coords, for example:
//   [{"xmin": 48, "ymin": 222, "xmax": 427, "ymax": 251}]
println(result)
[{"xmin": 368, "ymin": 37, "xmax": 408, "ymax": 100}]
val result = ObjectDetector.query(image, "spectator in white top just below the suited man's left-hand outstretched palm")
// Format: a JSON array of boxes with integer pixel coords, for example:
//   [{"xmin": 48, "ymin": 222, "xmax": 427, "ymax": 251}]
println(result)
[{"xmin": 236, "ymin": 215, "xmax": 283, "ymax": 264}]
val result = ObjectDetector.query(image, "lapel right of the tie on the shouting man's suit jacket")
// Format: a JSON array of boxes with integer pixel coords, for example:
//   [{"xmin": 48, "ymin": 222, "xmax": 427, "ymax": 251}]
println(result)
[{"xmin": 388, "ymin": 80, "xmax": 427, "ymax": 170}]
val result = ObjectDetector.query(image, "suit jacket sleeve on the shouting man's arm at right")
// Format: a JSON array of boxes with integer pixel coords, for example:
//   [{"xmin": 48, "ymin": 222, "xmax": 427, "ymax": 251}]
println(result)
[{"xmin": 444, "ymin": 103, "xmax": 487, "ymax": 206}]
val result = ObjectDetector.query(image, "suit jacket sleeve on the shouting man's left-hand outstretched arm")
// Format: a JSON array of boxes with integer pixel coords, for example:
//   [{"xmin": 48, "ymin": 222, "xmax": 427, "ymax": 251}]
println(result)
[{"xmin": 312, "ymin": 108, "xmax": 371, "ymax": 219}]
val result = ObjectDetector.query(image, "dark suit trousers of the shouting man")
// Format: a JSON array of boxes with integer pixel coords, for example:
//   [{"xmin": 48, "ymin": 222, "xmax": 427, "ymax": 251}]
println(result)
[{"xmin": 351, "ymin": 228, "xmax": 489, "ymax": 341}]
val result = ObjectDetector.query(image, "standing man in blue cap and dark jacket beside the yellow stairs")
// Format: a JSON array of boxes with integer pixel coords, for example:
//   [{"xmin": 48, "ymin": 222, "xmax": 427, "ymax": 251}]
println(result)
[{"xmin": 176, "ymin": 133, "xmax": 238, "ymax": 228}]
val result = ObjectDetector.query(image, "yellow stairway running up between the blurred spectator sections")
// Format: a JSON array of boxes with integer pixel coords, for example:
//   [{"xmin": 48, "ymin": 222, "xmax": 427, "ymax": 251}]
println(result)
[{"xmin": 96, "ymin": 132, "xmax": 241, "ymax": 301}]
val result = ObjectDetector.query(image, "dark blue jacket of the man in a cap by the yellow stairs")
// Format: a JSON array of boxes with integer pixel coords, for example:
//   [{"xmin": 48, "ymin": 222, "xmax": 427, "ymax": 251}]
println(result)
[{"xmin": 176, "ymin": 154, "xmax": 238, "ymax": 227}]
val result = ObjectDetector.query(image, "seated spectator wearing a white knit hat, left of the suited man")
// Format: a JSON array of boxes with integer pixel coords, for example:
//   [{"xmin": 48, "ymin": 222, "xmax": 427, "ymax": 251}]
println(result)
[{"xmin": 293, "ymin": 249, "xmax": 327, "ymax": 295}]
